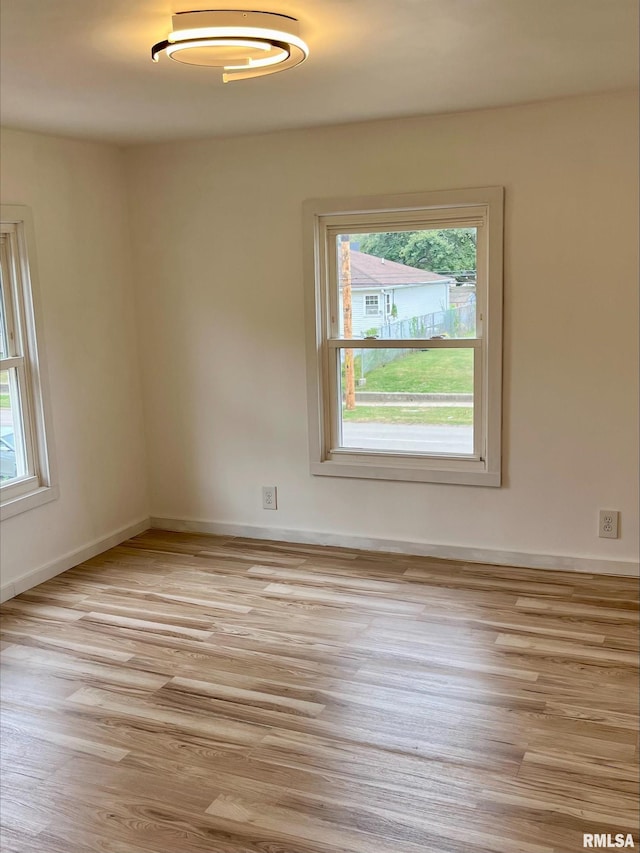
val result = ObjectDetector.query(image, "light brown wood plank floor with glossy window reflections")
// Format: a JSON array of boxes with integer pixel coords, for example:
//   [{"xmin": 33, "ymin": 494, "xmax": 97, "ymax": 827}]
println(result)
[{"xmin": 0, "ymin": 531, "xmax": 638, "ymax": 853}]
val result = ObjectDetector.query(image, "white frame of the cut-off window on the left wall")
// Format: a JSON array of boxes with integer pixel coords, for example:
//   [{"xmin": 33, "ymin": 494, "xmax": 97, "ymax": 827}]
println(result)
[{"xmin": 0, "ymin": 204, "xmax": 58, "ymax": 520}]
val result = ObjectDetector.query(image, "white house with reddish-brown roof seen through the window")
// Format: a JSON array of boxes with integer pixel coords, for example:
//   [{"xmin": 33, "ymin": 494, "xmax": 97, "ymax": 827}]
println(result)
[{"xmin": 340, "ymin": 249, "xmax": 456, "ymax": 338}]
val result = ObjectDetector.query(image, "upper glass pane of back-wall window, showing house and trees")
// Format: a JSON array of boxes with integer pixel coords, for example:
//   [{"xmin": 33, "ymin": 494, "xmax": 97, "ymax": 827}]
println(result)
[{"xmin": 336, "ymin": 228, "xmax": 477, "ymax": 338}]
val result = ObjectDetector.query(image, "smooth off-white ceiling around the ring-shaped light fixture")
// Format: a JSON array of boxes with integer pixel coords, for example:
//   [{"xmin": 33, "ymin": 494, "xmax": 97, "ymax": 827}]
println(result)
[{"xmin": 0, "ymin": 0, "xmax": 638, "ymax": 143}]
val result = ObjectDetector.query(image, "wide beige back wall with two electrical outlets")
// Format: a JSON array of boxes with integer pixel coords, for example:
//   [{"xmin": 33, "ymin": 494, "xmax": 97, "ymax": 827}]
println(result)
[{"xmin": 128, "ymin": 93, "xmax": 638, "ymax": 561}]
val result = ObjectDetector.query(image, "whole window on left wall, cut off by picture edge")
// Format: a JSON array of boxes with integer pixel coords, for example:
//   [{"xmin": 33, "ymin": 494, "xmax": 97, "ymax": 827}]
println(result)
[{"xmin": 0, "ymin": 205, "xmax": 57, "ymax": 518}]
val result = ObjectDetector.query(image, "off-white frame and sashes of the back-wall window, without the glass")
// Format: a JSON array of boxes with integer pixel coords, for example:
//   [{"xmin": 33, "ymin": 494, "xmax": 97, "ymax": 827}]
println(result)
[{"xmin": 303, "ymin": 187, "xmax": 504, "ymax": 486}]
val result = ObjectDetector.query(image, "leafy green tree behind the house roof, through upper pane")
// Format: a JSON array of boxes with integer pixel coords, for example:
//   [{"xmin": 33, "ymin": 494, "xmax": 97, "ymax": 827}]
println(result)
[{"xmin": 360, "ymin": 228, "xmax": 476, "ymax": 275}]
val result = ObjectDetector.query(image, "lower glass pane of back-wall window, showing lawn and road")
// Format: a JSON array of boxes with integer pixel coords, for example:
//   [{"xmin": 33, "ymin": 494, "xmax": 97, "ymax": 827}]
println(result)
[{"xmin": 340, "ymin": 349, "xmax": 473, "ymax": 455}]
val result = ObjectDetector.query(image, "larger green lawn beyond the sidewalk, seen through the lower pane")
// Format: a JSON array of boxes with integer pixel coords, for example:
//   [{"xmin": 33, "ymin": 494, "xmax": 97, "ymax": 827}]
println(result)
[{"xmin": 355, "ymin": 349, "xmax": 473, "ymax": 394}]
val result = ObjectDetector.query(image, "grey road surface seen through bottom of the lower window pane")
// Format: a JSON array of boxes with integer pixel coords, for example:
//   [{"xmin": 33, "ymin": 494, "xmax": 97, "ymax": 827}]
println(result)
[{"xmin": 342, "ymin": 423, "xmax": 473, "ymax": 453}]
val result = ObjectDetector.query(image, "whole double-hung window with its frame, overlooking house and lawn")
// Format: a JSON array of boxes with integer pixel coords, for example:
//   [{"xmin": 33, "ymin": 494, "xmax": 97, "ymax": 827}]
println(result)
[{"xmin": 304, "ymin": 187, "xmax": 503, "ymax": 486}]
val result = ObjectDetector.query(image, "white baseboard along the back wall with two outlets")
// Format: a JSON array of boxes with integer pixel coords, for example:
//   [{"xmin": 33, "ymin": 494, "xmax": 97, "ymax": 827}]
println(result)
[{"xmin": 151, "ymin": 518, "xmax": 640, "ymax": 577}]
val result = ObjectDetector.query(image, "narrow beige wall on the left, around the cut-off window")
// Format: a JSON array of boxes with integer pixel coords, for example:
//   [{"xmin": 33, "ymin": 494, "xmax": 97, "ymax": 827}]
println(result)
[{"xmin": 0, "ymin": 129, "xmax": 148, "ymax": 589}]
